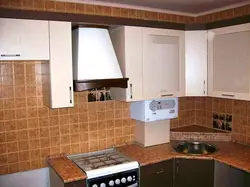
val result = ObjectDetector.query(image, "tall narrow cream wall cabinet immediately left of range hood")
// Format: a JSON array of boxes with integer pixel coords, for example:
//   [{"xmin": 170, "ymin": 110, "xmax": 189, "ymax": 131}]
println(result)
[{"xmin": 43, "ymin": 21, "xmax": 74, "ymax": 108}]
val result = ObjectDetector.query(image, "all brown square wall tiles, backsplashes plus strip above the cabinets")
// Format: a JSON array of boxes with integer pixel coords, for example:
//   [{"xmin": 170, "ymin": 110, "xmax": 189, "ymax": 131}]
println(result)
[{"xmin": 0, "ymin": 0, "xmax": 250, "ymax": 174}]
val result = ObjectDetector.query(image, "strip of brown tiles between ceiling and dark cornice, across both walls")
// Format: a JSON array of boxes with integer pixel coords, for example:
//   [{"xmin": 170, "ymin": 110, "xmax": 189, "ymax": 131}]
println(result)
[{"xmin": 0, "ymin": 0, "xmax": 250, "ymax": 23}]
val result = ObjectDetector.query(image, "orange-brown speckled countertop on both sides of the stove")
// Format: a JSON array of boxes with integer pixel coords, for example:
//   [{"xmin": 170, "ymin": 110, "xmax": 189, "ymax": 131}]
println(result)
[{"xmin": 47, "ymin": 142, "xmax": 250, "ymax": 183}]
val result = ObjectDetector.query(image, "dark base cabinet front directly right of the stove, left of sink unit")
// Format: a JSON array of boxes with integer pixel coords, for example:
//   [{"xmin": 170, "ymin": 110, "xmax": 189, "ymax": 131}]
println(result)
[{"xmin": 140, "ymin": 160, "xmax": 174, "ymax": 187}]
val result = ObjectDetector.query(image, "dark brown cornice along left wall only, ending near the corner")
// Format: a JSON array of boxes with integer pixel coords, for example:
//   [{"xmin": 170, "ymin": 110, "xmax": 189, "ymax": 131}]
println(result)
[{"xmin": 0, "ymin": 8, "xmax": 185, "ymax": 30}]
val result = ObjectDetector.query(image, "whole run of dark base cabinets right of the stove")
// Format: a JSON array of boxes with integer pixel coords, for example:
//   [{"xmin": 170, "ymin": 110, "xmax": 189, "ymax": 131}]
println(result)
[{"xmin": 140, "ymin": 158, "xmax": 250, "ymax": 187}]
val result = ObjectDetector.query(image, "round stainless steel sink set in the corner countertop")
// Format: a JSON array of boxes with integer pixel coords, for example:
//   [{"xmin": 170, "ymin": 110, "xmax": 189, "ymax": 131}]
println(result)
[{"xmin": 173, "ymin": 141, "xmax": 217, "ymax": 155}]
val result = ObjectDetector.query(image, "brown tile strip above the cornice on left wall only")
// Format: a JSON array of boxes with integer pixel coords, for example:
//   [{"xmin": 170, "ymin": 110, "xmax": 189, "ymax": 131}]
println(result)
[{"xmin": 0, "ymin": 0, "xmax": 189, "ymax": 23}]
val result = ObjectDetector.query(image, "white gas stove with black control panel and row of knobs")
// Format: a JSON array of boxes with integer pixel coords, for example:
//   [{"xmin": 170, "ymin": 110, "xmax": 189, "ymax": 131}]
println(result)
[{"xmin": 68, "ymin": 148, "xmax": 139, "ymax": 187}]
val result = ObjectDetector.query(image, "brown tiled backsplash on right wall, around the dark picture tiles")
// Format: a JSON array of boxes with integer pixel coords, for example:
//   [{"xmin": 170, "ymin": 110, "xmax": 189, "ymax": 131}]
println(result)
[{"xmin": 195, "ymin": 97, "xmax": 250, "ymax": 145}]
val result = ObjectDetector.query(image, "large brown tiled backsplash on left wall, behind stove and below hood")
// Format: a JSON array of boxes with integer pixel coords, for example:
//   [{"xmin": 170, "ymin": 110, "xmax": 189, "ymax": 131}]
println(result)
[{"xmin": 0, "ymin": 61, "xmax": 135, "ymax": 174}]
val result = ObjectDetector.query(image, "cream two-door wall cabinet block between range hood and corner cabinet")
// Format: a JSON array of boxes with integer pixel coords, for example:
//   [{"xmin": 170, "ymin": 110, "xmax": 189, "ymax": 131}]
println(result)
[{"xmin": 110, "ymin": 26, "xmax": 185, "ymax": 101}]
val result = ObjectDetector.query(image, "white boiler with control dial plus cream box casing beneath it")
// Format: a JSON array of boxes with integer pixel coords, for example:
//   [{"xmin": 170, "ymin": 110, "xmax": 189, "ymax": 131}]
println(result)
[{"xmin": 130, "ymin": 98, "xmax": 178, "ymax": 147}]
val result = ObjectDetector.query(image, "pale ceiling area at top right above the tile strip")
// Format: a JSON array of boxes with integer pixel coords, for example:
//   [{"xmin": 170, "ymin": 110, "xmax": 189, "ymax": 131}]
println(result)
[{"xmin": 78, "ymin": 0, "xmax": 249, "ymax": 14}]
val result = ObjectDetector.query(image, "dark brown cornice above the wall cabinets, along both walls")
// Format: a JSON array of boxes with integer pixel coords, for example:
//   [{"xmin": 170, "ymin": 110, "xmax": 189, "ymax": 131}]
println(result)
[{"xmin": 0, "ymin": 5, "xmax": 250, "ymax": 30}]
